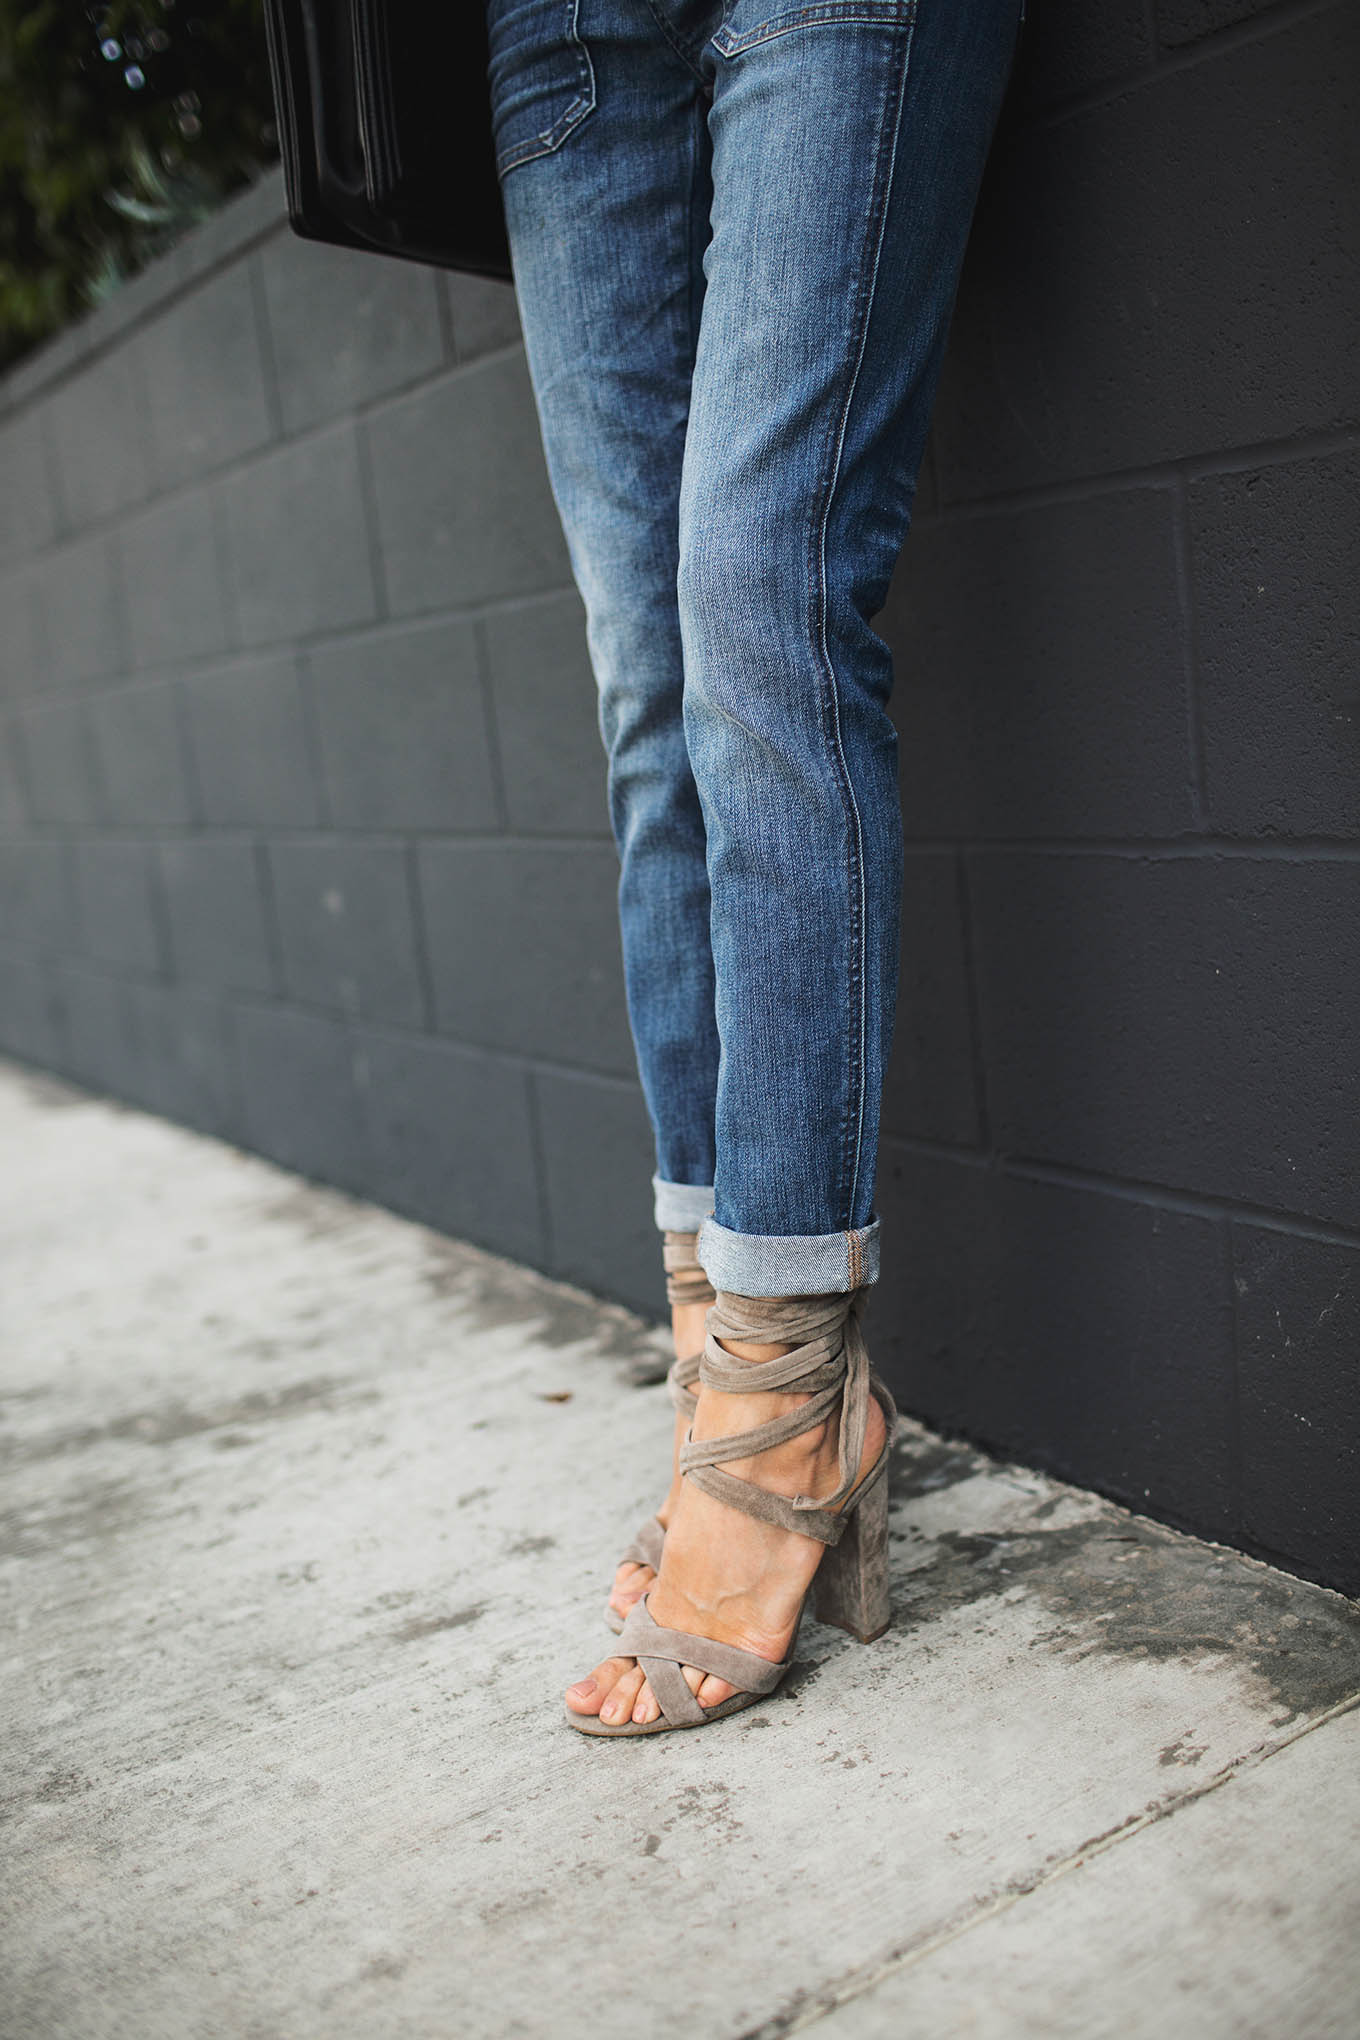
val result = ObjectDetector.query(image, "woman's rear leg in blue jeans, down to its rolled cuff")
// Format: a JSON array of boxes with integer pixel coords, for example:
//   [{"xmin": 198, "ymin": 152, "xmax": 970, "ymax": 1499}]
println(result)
[{"xmin": 487, "ymin": 0, "xmax": 718, "ymax": 1224}]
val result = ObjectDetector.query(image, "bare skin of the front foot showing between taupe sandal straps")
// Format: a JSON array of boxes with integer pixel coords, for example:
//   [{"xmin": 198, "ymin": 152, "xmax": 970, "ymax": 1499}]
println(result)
[{"xmin": 567, "ymin": 1342, "xmax": 887, "ymax": 1724}]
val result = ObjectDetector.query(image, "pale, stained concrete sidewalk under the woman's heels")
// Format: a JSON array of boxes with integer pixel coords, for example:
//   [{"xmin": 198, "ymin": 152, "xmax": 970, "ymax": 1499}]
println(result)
[{"xmin": 0, "ymin": 1071, "xmax": 1360, "ymax": 2040}]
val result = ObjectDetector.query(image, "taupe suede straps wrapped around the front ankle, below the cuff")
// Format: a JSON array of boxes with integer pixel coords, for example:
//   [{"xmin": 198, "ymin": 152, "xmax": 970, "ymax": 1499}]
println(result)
[{"xmin": 679, "ymin": 1289, "xmax": 895, "ymax": 1544}]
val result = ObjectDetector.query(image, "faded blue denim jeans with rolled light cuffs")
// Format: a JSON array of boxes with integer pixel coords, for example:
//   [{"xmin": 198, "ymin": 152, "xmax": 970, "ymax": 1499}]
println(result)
[{"xmin": 487, "ymin": 0, "xmax": 1022, "ymax": 1295}]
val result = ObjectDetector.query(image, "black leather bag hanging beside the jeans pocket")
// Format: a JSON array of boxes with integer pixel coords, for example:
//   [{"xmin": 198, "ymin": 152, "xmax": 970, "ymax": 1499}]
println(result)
[{"xmin": 265, "ymin": 0, "xmax": 510, "ymax": 277}]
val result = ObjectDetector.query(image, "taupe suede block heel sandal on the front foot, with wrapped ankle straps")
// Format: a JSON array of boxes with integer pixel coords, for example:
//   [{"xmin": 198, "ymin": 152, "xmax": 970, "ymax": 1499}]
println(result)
[{"xmin": 567, "ymin": 1289, "xmax": 897, "ymax": 1736}]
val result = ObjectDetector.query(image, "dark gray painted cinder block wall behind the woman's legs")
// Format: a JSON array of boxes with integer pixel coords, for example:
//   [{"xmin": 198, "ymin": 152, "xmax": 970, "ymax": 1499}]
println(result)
[{"xmin": 0, "ymin": 0, "xmax": 1360, "ymax": 1591}]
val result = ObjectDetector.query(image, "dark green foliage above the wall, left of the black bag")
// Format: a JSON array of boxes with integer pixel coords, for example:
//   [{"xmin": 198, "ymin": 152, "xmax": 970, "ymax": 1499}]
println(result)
[{"xmin": 0, "ymin": 0, "xmax": 277, "ymax": 367}]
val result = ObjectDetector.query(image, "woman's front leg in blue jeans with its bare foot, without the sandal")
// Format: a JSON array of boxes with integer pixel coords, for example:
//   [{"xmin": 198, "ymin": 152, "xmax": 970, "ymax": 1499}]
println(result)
[{"xmin": 569, "ymin": 0, "xmax": 1019, "ymax": 1722}]
